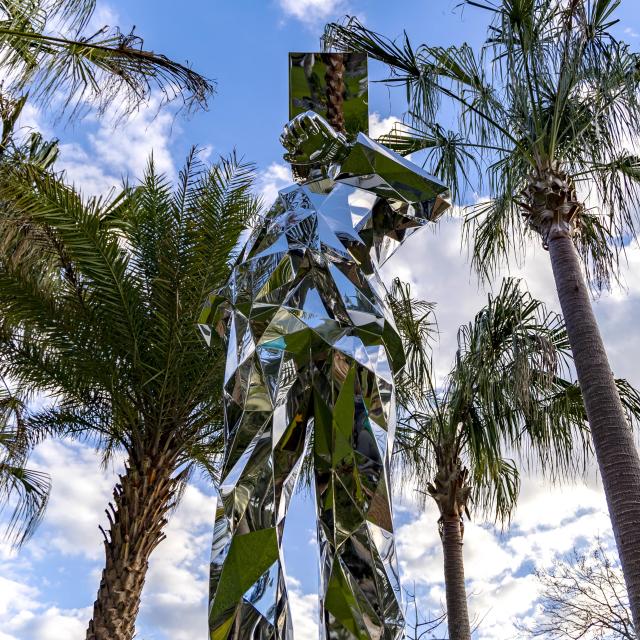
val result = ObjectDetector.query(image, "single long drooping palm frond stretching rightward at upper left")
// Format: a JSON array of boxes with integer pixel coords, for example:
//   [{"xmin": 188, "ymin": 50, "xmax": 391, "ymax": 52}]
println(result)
[{"xmin": 0, "ymin": 24, "xmax": 214, "ymax": 116}]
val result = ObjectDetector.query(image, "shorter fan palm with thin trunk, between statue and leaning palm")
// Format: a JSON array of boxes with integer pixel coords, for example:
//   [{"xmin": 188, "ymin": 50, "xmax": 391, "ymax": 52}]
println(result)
[{"xmin": 391, "ymin": 279, "xmax": 640, "ymax": 640}]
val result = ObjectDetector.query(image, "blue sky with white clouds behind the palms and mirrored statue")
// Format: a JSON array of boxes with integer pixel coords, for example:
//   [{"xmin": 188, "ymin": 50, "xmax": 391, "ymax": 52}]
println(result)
[{"xmin": 0, "ymin": 0, "xmax": 640, "ymax": 640}]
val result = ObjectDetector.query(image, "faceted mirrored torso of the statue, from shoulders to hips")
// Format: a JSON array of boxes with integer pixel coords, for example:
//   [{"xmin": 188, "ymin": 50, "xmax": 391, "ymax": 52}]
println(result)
[{"xmin": 220, "ymin": 176, "xmax": 403, "ymax": 382}]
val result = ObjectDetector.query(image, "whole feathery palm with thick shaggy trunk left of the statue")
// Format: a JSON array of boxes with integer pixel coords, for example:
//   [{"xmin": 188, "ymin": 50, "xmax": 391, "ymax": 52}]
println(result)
[{"xmin": 0, "ymin": 153, "xmax": 258, "ymax": 640}]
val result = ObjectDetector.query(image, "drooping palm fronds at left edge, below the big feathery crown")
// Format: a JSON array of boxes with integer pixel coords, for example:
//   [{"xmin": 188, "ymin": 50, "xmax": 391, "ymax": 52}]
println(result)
[{"xmin": 0, "ymin": 378, "xmax": 49, "ymax": 546}]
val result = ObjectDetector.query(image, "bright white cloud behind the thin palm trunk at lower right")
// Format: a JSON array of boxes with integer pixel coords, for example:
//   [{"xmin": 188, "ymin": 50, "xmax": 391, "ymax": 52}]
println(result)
[{"xmin": 397, "ymin": 478, "xmax": 612, "ymax": 640}]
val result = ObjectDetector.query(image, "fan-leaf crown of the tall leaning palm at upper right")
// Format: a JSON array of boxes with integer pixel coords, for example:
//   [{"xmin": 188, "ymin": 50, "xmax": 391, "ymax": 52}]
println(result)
[{"xmin": 325, "ymin": 0, "xmax": 640, "ymax": 288}]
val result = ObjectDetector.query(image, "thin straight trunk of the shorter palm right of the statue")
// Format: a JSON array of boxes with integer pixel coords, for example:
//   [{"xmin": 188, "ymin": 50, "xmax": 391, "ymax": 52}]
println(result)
[{"xmin": 442, "ymin": 516, "xmax": 471, "ymax": 640}]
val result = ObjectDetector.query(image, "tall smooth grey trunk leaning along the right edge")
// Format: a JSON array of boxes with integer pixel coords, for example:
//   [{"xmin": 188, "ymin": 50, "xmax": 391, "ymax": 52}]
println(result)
[{"xmin": 548, "ymin": 234, "xmax": 640, "ymax": 629}]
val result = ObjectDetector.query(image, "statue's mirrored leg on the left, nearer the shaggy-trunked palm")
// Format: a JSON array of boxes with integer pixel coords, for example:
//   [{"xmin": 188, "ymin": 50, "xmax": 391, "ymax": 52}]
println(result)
[{"xmin": 209, "ymin": 352, "xmax": 310, "ymax": 640}]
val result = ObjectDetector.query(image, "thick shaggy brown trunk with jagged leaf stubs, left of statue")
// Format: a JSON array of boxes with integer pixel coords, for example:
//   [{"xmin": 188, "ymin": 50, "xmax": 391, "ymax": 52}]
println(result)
[{"xmin": 86, "ymin": 454, "xmax": 177, "ymax": 640}]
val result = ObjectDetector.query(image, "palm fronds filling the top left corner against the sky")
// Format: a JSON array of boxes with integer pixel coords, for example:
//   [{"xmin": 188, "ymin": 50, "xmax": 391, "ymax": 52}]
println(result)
[{"xmin": 0, "ymin": 0, "xmax": 214, "ymax": 121}]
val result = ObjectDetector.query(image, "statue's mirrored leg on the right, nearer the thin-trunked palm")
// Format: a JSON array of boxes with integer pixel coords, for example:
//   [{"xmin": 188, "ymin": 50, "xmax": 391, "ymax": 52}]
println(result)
[{"xmin": 314, "ymin": 351, "xmax": 404, "ymax": 640}]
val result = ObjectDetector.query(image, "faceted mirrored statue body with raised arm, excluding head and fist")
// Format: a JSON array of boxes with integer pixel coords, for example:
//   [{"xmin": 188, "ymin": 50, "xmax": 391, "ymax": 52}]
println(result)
[{"xmin": 201, "ymin": 124, "xmax": 448, "ymax": 640}]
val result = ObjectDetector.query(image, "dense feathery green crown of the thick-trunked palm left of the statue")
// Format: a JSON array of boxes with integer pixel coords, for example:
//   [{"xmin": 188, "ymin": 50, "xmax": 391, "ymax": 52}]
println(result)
[{"xmin": 0, "ymin": 149, "xmax": 256, "ymax": 480}]
